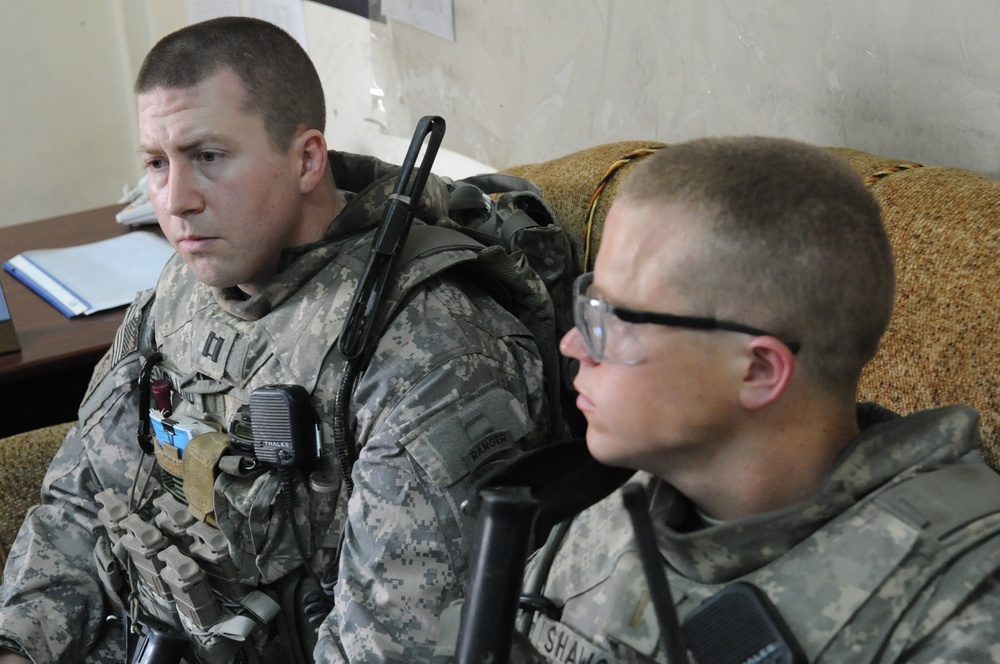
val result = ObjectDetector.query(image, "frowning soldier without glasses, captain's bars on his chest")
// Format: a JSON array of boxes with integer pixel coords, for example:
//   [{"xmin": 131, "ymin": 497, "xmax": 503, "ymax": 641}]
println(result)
[{"xmin": 0, "ymin": 18, "xmax": 555, "ymax": 664}]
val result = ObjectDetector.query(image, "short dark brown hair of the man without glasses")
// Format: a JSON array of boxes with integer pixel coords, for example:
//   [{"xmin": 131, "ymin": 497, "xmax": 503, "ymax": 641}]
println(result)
[{"xmin": 135, "ymin": 16, "xmax": 326, "ymax": 150}]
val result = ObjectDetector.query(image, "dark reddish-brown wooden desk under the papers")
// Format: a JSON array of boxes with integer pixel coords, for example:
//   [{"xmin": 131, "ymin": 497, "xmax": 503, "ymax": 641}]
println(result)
[{"xmin": 0, "ymin": 205, "xmax": 148, "ymax": 436}]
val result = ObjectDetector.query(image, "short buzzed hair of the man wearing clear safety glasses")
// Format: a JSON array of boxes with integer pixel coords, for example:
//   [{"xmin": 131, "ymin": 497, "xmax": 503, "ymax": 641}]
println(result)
[{"xmin": 618, "ymin": 137, "xmax": 895, "ymax": 389}]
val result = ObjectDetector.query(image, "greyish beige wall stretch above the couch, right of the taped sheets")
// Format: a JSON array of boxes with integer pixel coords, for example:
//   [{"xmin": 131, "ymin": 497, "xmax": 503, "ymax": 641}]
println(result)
[{"xmin": 375, "ymin": 0, "xmax": 1000, "ymax": 177}]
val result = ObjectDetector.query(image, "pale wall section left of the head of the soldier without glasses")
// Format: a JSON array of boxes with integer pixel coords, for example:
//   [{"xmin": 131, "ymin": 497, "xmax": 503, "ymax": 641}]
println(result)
[{"xmin": 0, "ymin": 0, "xmax": 183, "ymax": 228}]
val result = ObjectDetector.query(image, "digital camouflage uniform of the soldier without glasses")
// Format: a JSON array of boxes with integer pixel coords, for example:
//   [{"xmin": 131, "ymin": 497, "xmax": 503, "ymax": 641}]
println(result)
[{"xmin": 0, "ymin": 153, "xmax": 548, "ymax": 664}]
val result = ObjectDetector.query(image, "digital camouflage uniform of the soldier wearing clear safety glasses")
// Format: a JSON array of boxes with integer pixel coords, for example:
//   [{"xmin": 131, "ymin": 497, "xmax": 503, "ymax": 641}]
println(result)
[{"xmin": 526, "ymin": 405, "xmax": 1000, "ymax": 664}]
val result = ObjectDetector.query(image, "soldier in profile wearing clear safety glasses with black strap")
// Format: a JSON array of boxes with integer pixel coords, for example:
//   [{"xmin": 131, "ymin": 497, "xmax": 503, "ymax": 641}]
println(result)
[{"xmin": 522, "ymin": 137, "xmax": 1000, "ymax": 664}]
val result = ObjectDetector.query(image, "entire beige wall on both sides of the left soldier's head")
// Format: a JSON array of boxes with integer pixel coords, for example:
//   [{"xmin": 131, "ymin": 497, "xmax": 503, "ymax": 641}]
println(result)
[{"xmin": 0, "ymin": 0, "xmax": 1000, "ymax": 231}]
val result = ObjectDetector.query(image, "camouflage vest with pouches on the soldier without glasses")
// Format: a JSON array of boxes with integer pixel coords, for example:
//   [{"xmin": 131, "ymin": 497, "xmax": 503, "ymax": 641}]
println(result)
[{"xmin": 96, "ymin": 220, "xmax": 512, "ymax": 663}]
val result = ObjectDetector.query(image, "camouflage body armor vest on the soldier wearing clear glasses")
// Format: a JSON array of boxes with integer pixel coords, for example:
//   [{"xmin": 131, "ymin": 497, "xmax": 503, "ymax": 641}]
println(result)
[{"xmin": 529, "ymin": 463, "xmax": 1000, "ymax": 664}]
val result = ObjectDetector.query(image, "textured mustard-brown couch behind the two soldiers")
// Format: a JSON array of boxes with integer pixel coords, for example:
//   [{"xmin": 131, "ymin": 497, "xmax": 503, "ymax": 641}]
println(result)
[{"xmin": 0, "ymin": 141, "xmax": 1000, "ymax": 564}]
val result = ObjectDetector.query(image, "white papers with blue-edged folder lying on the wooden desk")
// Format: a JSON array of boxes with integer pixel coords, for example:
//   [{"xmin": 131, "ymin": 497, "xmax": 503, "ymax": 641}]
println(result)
[{"xmin": 3, "ymin": 231, "xmax": 174, "ymax": 318}]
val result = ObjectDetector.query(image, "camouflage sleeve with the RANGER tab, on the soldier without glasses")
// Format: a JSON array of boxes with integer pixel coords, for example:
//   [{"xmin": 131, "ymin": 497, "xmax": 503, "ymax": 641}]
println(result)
[{"xmin": 315, "ymin": 284, "xmax": 546, "ymax": 662}]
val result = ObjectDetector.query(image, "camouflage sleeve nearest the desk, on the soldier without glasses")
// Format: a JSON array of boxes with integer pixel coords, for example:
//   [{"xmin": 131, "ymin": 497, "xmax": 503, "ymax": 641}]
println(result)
[{"xmin": 0, "ymin": 292, "xmax": 152, "ymax": 662}]
